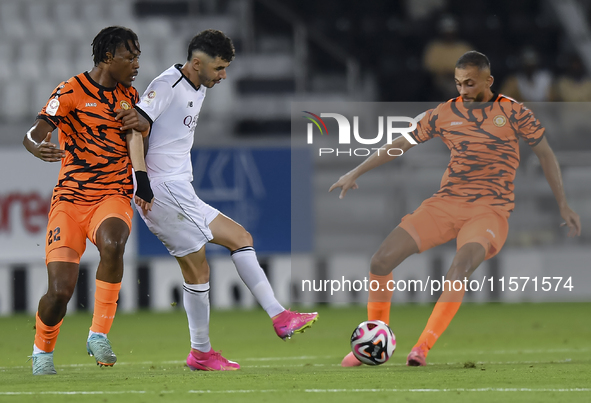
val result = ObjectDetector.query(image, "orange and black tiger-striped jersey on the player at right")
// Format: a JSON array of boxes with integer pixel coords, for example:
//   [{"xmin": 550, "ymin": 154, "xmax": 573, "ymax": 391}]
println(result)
[{"xmin": 411, "ymin": 94, "xmax": 545, "ymax": 217}]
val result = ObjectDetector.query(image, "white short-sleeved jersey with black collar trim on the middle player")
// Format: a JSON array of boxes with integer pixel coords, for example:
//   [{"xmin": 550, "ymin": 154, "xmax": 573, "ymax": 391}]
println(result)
[{"xmin": 136, "ymin": 64, "xmax": 205, "ymax": 186}]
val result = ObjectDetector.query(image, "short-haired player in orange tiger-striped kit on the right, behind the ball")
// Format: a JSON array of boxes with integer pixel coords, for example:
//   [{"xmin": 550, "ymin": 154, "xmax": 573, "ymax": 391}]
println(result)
[{"xmin": 330, "ymin": 51, "xmax": 581, "ymax": 367}]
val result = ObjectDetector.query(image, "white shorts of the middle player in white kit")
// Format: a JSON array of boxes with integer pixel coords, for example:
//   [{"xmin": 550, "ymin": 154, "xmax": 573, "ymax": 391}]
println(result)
[{"xmin": 137, "ymin": 181, "xmax": 220, "ymax": 257}]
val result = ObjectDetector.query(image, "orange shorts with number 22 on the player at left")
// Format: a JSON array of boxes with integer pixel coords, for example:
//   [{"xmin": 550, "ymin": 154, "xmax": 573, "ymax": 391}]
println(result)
[{"xmin": 45, "ymin": 196, "xmax": 133, "ymax": 263}]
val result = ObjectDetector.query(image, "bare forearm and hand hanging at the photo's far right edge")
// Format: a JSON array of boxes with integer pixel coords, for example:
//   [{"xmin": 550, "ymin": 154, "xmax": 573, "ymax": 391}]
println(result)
[{"xmin": 532, "ymin": 137, "xmax": 581, "ymax": 237}]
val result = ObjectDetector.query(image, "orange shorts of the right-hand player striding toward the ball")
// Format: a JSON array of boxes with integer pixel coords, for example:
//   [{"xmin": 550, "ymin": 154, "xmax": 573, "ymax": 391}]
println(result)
[{"xmin": 400, "ymin": 197, "xmax": 509, "ymax": 259}]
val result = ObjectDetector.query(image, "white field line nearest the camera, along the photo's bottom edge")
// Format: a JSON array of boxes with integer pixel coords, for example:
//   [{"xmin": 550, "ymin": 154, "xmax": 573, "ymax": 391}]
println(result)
[{"xmin": 0, "ymin": 388, "xmax": 591, "ymax": 396}]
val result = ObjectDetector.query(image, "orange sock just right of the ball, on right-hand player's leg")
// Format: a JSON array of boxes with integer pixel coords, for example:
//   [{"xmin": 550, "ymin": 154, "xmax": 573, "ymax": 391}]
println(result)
[{"xmin": 414, "ymin": 290, "xmax": 464, "ymax": 357}]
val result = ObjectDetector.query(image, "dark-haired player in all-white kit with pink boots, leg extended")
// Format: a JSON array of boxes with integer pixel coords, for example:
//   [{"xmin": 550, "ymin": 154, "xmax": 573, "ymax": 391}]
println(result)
[{"xmin": 136, "ymin": 30, "xmax": 318, "ymax": 371}]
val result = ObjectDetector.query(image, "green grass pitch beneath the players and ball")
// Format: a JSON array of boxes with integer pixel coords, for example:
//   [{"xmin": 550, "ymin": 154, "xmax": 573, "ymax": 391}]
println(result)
[{"xmin": 0, "ymin": 303, "xmax": 591, "ymax": 403}]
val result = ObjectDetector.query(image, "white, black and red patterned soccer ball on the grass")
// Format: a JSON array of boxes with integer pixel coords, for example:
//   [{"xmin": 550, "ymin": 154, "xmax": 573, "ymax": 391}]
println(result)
[{"xmin": 351, "ymin": 320, "xmax": 396, "ymax": 365}]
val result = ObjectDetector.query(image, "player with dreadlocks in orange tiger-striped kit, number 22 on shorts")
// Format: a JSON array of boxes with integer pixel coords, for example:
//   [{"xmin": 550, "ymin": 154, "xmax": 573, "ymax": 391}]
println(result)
[{"xmin": 23, "ymin": 27, "xmax": 153, "ymax": 375}]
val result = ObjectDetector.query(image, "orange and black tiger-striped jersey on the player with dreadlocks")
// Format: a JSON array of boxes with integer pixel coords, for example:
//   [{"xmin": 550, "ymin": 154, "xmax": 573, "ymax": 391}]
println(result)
[{"xmin": 37, "ymin": 73, "xmax": 139, "ymax": 204}]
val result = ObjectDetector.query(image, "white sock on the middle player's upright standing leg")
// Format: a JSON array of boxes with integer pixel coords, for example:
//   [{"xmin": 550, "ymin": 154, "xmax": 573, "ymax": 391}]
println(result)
[{"xmin": 183, "ymin": 282, "xmax": 211, "ymax": 353}]
